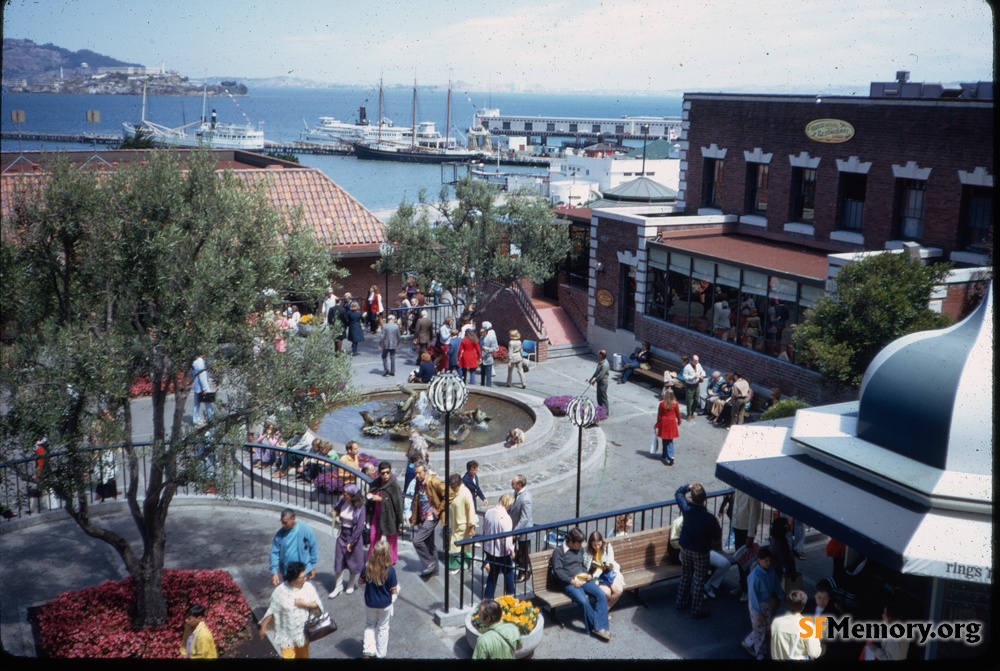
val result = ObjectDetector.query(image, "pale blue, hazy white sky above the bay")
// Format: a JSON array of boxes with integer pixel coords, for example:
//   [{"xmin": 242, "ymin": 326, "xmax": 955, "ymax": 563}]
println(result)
[{"xmin": 3, "ymin": 0, "xmax": 994, "ymax": 94}]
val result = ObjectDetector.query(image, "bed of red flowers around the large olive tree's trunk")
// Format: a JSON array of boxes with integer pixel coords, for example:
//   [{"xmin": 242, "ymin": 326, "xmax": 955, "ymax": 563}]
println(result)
[{"xmin": 38, "ymin": 569, "xmax": 253, "ymax": 659}]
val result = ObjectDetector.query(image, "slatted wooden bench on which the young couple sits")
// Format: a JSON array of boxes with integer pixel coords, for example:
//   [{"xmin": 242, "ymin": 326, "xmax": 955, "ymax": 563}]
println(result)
[{"xmin": 528, "ymin": 527, "xmax": 681, "ymax": 627}]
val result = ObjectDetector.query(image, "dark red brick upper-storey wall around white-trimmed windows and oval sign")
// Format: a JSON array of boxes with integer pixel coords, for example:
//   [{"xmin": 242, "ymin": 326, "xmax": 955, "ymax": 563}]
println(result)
[{"xmin": 685, "ymin": 96, "xmax": 994, "ymax": 254}]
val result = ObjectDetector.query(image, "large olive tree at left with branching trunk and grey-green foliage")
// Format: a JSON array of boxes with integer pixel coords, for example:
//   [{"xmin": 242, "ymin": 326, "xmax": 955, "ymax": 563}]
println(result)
[{"xmin": 0, "ymin": 151, "xmax": 354, "ymax": 626}]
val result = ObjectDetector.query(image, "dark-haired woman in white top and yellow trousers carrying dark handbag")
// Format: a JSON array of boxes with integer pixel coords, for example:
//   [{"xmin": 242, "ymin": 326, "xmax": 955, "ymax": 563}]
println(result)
[{"xmin": 259, "ymin": 562, "xmax": 320, "ymax": 659}]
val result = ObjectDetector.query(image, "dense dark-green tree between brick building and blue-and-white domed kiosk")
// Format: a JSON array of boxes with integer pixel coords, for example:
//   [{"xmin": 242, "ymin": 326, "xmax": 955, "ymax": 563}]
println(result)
[{"xmin": 792, "ymin": 253, "xmax": 951, "ymax": 387}]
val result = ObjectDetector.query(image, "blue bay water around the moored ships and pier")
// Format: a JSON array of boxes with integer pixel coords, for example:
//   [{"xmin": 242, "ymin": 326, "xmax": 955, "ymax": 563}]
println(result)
[{"xmin": 0, "ymin": 87, "xmax": 682, "ymax": 210}]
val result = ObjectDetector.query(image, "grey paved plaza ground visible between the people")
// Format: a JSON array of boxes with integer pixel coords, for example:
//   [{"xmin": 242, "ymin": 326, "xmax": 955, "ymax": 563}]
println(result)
[{"xmin": 0, "ymin": 341, "xmax": 830, "ymax": 659}]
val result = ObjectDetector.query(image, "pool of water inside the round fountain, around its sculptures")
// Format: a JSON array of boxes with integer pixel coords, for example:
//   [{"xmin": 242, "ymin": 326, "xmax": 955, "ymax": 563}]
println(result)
[{"xmin": 315, "ymin": 385, "xmax": 548, "ymax": 454}]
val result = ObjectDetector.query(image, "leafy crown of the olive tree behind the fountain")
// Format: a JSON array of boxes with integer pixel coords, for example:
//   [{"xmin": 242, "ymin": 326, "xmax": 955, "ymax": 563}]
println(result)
[{"xmin": 382, "ymin": 177, "xmax": 570, "ymax": 310}]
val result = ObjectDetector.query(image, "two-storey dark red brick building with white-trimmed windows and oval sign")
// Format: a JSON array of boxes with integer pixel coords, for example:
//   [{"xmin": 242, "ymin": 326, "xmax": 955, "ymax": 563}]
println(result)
[{"xmin": 558, "ymin": 73, "xmax": 995, "ymax": 403}]
